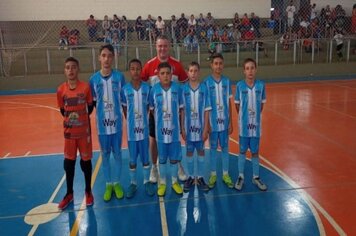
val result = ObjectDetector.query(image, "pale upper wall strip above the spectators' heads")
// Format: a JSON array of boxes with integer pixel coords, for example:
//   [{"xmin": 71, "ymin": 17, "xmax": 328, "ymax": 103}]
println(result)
[{"xmin": 0, "ymin": 0, "xmax": 271, "ymax": 21}]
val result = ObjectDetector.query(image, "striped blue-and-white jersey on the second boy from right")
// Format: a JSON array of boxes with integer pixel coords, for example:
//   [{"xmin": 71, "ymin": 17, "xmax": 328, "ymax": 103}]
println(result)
[{"xmin": 205, "ymin": 75, "xmax": 232, "ymax": 132}]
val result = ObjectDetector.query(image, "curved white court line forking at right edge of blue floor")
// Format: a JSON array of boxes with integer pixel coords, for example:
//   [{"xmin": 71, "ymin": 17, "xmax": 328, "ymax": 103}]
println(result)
[{"xmin": 230, "ymin": 138, "xmax": 346, "ymax": 235}]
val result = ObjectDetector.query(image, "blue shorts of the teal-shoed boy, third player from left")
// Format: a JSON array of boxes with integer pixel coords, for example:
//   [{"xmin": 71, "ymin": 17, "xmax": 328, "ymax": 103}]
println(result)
[{"xmin": 127, "ymin": 138, "xmax": 149, "ymax": 166}]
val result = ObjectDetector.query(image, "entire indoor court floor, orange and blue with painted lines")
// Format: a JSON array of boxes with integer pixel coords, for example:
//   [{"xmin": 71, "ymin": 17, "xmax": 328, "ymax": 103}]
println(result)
[{"xmin": 0, "ymin": 80, "xmax": 356, "ymax": 235}]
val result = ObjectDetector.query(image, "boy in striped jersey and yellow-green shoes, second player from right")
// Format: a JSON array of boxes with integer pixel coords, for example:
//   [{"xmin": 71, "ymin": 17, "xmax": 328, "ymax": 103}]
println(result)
[{"xmin": 205, "ymin": 53, "xmax": 234, "ymax": 188}]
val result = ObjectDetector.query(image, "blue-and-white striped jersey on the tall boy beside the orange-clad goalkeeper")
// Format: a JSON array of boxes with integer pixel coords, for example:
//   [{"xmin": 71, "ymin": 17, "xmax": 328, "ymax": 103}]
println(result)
[{"xmin": 90, "ymin": 70, "xmax": 125, "ymax": 135}]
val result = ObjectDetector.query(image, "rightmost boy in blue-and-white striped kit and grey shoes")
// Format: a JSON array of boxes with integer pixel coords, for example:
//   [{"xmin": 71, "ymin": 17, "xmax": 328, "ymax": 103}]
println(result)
[{"xmin": 235, "ymin": 58, "xmax": 267, "ymax": 191}]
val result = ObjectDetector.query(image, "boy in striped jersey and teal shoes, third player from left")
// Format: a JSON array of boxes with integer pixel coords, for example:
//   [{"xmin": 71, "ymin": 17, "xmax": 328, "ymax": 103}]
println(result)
[{"xmin": 122, "ymin": 59, "xmax": 154, "ymax": 198}]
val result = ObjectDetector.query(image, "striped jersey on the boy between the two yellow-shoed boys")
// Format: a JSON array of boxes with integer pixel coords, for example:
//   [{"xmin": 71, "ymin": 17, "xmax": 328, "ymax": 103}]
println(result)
[{"xmin": 182, "ymin": 83, "xmax": 211, "ymax": 142}]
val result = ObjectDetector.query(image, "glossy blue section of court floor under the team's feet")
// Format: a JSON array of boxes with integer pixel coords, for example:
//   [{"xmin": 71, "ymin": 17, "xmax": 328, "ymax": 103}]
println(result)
[{"xmin": 0, "ymin": 150, "xmax": 324, "ymax": 235}]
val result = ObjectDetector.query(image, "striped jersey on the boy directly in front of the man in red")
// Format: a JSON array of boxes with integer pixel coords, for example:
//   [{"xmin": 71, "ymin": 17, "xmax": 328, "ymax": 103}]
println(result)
[{"xmin": 149, "ymin": 82, "xmax": 183, "ymax": 143}]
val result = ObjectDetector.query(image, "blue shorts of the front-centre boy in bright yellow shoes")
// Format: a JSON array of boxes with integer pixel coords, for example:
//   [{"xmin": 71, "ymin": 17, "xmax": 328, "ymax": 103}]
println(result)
[{"xmin": 157, "ymin": 142, "xmax": 182, "ymax": 164}]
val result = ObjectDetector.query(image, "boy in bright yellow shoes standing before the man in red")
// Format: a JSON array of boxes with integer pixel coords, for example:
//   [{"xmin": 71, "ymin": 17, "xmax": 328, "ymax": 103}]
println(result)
[{"xmin": 150, "ymin": 62, "xmax": 184, "ymax": 197}]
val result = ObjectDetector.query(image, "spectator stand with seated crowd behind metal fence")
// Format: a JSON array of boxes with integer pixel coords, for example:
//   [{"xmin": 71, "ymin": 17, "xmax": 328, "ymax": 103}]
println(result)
[{"xmin": 0, "ymin": 0, "xmax": 356, "ymax": 77}]
